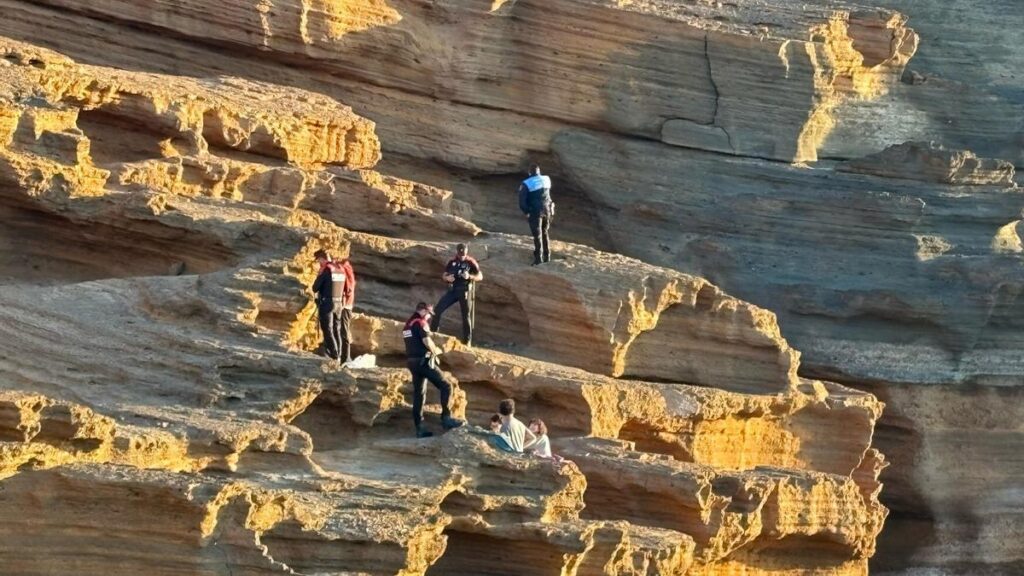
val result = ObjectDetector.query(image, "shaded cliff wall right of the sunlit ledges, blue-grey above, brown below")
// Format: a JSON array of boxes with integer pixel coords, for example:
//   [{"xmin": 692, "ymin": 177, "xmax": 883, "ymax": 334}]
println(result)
[{"xmin": 554, "ymin": 123, "xmax": 1024, "ymax": 572}]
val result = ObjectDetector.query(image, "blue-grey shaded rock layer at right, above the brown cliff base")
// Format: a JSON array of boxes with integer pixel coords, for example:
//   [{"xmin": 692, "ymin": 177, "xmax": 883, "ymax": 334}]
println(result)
[{"xmin": 554, "ymin": 127, "xmax": 1022, "ymax": 385}]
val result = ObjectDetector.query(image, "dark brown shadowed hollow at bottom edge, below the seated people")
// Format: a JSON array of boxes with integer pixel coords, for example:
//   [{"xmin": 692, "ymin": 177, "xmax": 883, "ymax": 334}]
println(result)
[{"xmin": 427, "ymin": 530, "xmax": 565, "ymax": 576}]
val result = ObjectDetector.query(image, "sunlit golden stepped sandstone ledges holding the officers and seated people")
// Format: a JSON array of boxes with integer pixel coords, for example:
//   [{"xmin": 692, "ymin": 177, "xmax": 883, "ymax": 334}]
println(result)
[{"xmin": 0, "ymin": 40, "xmax": 886, "ymax": 576}]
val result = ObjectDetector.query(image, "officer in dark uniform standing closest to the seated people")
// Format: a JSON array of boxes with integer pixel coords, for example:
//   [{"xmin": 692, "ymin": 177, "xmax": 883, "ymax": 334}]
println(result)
[{"xmin": 401, "ymin": 302, "xmax": 465, "ymax": 438}]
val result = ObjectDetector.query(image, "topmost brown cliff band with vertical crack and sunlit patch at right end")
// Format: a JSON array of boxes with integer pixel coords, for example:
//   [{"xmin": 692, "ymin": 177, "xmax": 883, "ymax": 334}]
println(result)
[{"xmin": 0, "ymin": 0, "xmax": 918, "ymax": 166}]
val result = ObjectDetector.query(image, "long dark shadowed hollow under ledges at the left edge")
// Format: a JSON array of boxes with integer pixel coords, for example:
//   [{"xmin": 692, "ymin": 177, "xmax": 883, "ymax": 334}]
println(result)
[{"xmin": 0, "ymin": 196, "xmax": 237, "ymax": 285}]
